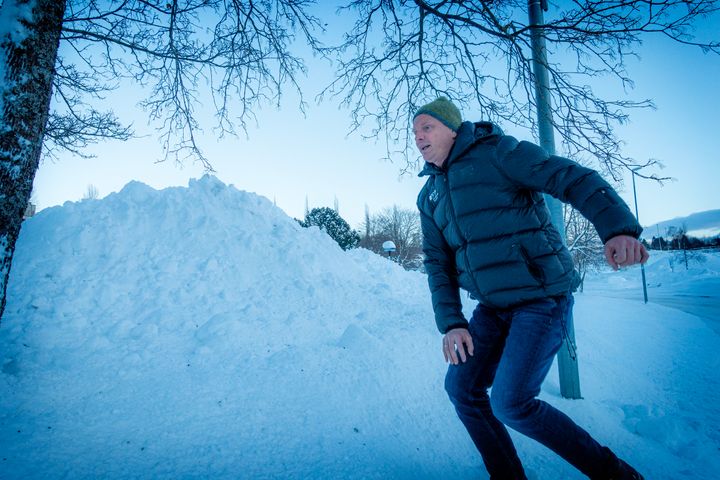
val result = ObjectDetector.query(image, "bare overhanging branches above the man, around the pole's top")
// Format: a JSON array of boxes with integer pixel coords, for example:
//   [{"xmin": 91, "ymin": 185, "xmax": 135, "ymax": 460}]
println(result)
[{"xmin": 321, "ymin": 0, "xmax": 720, "ymax": 181}]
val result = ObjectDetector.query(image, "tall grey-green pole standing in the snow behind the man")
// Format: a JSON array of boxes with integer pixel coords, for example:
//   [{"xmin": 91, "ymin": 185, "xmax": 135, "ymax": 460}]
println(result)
[{"xmin": 528, "ymin": 0, "xmax": 582, "ymax": 399}]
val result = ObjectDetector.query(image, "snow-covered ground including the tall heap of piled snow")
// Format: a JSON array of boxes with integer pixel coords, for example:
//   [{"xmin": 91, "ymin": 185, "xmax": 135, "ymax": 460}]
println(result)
[{"xmin": 0, "ymin": 177, "xmax": 720, "ymax": 480}]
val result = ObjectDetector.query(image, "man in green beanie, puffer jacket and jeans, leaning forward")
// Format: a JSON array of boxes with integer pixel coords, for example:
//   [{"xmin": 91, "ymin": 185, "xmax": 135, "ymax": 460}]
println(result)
[{"xmin": 413, "ymin": 97, "xmax": 648, "ymax": 480}]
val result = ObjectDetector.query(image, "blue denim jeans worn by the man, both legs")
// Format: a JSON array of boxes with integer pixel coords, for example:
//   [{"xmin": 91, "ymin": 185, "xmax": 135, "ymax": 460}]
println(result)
[{"xmin": 445, "ymin": 295, "xmax": 609, "ymax": 480}]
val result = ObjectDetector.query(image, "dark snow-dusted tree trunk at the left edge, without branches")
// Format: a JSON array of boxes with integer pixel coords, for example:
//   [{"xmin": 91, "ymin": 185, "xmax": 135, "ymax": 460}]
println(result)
[{"xmin": 0, "ymin": 0, "xmax": 65, "ymax": 318}]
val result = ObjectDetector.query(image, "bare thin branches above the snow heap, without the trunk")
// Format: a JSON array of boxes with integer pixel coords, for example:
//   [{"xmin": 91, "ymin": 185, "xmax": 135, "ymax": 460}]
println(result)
[{"xmin": 55, "ymin": 0, "xmax": 321, "ymax": 170}]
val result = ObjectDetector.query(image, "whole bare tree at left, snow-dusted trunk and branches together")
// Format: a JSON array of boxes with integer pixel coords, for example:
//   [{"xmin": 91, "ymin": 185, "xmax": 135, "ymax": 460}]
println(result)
[{"xmin": 0, "ymin": 0, "xmax": 322, "ymax": 322}]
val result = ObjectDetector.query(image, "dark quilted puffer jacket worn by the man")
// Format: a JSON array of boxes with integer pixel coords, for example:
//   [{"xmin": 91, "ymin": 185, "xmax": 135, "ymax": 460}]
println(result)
[{"xmin": 417, "ymin": 122, "xmax": 642, "ymax": 333}]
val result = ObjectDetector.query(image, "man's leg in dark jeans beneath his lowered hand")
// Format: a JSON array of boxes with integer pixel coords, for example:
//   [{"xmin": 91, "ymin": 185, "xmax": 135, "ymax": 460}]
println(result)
[{"xmin": 445, "ymin": 305, "xmax": 526, "ymax": 480}]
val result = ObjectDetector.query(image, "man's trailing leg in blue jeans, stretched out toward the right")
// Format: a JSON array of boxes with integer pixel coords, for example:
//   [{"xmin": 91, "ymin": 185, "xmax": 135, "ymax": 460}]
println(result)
[{"xmin": 491, "ymin": 296, "xmax": 632, "ymax": 479}]
